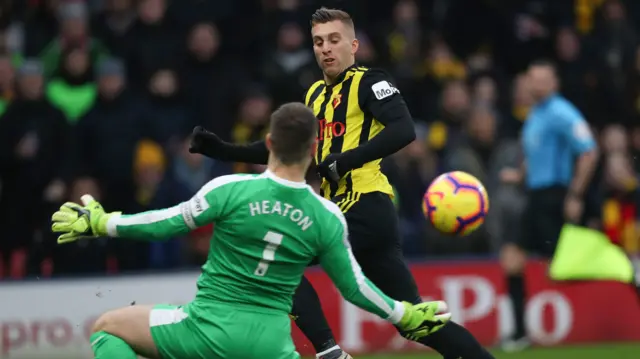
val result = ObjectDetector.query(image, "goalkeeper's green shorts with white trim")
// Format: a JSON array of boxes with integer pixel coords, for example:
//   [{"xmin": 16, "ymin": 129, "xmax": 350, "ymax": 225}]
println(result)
[{"xmin": 149, "ymin": 303, "xmax": 300, "ymax": 359}]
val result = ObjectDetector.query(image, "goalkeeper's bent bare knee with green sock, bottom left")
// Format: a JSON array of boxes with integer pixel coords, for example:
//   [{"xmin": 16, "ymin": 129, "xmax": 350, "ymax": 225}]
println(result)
[{"xmin": 90, "ymin": 306, "xmax": 159, "ymax": 359}]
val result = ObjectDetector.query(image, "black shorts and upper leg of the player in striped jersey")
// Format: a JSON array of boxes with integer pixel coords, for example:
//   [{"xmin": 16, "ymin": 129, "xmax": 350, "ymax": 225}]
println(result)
[{"xmin": 332, "ymin": 192, "xmax": 421, "ymax": 303}]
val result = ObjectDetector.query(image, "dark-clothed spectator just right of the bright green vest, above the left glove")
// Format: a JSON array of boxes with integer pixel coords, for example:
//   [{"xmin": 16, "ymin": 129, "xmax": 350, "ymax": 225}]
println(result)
[{"xmin": 73, "ymin": 59, "xmax": 154, "ymax": 211}]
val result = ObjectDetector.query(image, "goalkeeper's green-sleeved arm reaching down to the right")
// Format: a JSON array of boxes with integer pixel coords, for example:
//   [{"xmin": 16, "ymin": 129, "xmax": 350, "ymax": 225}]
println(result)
[{"xmin": 319, "ymin": 206, "xmax": 405, "ymax": 324}]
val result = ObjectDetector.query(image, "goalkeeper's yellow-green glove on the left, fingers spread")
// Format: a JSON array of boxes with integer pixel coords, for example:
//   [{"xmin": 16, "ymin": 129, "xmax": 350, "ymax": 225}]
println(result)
[{"xmin": 51, "ymin": 194, "xmax": 120, "ymax": 244}]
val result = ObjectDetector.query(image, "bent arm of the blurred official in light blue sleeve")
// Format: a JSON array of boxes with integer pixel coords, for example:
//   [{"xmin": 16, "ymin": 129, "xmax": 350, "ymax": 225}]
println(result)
[{"xmin": 555, "ymin": 108, "xmax": 598, "ymax": 198}]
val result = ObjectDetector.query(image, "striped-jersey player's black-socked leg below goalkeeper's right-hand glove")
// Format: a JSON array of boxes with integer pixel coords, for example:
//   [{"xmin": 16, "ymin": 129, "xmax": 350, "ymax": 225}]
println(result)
[{"xmin": 420, "ymin": 322, "xmax": 495, "ymax": 359}]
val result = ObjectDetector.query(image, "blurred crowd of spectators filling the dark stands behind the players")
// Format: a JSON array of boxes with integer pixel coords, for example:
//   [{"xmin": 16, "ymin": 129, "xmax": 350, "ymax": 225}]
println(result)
[{"xmin": 0, "ymin": 0, "xmax": 640, "ymax": 278}]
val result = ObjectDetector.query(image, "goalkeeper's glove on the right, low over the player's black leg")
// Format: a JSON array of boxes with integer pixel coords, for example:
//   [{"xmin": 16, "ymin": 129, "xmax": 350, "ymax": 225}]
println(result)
[{"xmin": 397, "ymin": 301, "xmax": 451, "ymax": 341}]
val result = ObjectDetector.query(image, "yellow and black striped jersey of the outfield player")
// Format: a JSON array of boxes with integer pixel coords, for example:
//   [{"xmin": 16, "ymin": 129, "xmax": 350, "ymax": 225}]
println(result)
[{"xmin": 305, "ymin": 65, "xmax": 413, "ymax": 198}]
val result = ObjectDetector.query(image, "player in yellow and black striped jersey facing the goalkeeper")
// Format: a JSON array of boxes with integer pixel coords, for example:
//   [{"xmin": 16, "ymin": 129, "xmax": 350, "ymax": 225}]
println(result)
[{"xmin": 191, "ymin": 8, "xmax": 492, "ymax": 359}]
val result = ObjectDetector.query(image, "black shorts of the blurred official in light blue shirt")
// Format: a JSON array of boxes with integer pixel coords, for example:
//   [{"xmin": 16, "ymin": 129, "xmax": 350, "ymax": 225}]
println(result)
[{"xmin": 518, "ymin": 187, "xmax": 567, "ymax": 258}]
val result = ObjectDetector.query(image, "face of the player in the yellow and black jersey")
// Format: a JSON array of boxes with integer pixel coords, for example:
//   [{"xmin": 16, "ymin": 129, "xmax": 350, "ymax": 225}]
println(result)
[{"xmin": 311, "ymin": 20, "xmax": 358, "ymax": 78}]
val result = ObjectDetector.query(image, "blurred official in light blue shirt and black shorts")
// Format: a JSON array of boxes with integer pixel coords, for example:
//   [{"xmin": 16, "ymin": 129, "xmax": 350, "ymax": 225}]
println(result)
[{"xmin": 501, "ymin": 61, "xmax": 598, "ymax": 351}]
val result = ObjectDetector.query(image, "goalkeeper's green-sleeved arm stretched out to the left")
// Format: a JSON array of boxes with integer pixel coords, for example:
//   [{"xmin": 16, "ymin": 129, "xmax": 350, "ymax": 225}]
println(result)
[{"xmin": 106, "ymin": 176, "xmax": 236, "ymax": 240}]
